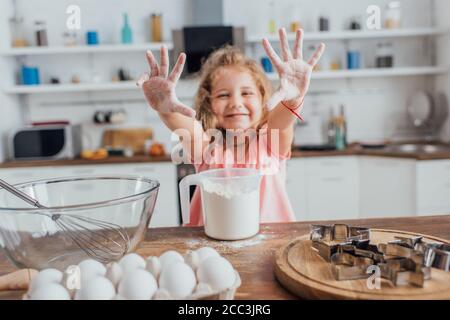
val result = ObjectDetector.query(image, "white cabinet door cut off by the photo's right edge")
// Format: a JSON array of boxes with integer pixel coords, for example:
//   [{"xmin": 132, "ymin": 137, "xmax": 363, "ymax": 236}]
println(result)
[{"xmin": 416, "ymin": 160, "xmax": 450, "ymax": 215}]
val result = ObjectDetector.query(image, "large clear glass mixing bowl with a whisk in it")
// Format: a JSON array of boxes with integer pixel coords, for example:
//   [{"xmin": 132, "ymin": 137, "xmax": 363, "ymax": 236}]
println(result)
[{"xmin": 0, "ymin": 176, "xmax": 159, "ymax": 270}]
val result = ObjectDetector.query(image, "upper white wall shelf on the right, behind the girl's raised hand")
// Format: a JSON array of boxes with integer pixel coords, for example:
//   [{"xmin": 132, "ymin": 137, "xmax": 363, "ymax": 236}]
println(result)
[{"xmin": 247, "ymin": 28, "xmax": 449, "ymax": 44}]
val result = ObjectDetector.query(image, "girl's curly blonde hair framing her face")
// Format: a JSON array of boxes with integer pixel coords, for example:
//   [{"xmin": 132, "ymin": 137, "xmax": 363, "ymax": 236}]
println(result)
[{"xmin": 194, "ymin": 45, "xmax": 272, "ymax": 130}]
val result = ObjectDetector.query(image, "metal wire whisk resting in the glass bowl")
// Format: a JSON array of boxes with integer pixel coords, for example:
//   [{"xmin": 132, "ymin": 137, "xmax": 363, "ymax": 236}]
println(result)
[{"xmin": 0, "ymin": 179, "xmax": 130, "ymax": 263}]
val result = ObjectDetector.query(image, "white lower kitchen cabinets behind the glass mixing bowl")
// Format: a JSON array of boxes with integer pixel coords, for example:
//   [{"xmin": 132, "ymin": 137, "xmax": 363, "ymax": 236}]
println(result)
[{"xmin": 0, "ymin": 162, "xmax": 180, "ymax": 227}]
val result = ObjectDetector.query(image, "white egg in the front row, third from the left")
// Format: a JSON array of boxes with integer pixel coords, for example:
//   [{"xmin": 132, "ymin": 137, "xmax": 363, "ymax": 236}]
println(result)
[{"xmin": 118, "ymin": 269, "xmax": 158, "ymax": 300}]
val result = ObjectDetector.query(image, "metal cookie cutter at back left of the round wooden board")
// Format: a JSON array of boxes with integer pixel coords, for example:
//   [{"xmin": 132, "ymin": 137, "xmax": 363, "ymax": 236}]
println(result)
[{"xmin": 310, "ymin": 224, "xmax": 370, "ymax": 262}]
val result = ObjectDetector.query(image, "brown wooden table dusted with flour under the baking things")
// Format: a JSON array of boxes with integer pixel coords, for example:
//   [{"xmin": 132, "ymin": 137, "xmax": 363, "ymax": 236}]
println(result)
[{"xmin": 0, "ymin": 215, "xmax": 450, "ymax": 300}]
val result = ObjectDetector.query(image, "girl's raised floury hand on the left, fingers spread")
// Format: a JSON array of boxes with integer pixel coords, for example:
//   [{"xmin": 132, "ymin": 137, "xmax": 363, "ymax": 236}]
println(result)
[{"xmin": 137, "ymin": 46, "xmax": 195, "ymax": 117}]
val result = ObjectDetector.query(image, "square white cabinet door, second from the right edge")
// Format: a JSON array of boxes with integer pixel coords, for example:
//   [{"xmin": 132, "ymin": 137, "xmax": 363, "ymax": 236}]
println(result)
[{"xmin": 360, "ymin": 157, "xmax": 416, "ymax": 218}]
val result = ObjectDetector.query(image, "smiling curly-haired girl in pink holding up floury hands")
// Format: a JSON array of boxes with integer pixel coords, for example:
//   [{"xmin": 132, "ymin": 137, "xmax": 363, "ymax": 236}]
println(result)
[{"xmin": 138, "ymin": 29, "xmax": 325, "ymax": 225}]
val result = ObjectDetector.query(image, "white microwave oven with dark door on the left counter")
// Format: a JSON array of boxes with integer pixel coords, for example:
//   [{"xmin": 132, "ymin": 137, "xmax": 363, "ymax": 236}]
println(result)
[{"xmin": 8, "ymin": 124, "xmax": 82, "ymax": 160}]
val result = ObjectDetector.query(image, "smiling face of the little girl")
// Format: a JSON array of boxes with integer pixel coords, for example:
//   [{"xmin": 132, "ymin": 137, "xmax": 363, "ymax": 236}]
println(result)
[{"xmin": 211, "ymin": 67, "xmax": 263, "ymax": 129}]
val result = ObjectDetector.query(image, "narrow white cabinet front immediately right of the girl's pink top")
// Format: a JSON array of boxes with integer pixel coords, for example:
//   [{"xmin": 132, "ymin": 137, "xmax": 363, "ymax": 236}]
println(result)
[{"xmin": 286, "ymin": 158, "xmax": 308, "ymax": 221}]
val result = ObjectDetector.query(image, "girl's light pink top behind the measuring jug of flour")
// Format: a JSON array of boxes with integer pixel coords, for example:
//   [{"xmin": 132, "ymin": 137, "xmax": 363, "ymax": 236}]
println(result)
[{"xmin": 187, "ymin": 126, "xmax": 295, "ymax": 226}]
